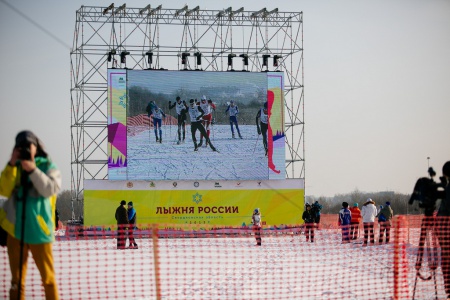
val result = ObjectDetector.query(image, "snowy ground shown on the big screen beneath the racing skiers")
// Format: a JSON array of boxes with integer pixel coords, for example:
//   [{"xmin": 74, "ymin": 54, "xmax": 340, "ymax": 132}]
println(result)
[{"xmin": 127, "ymin": 125, "xmax": 284, "ymax": 180}]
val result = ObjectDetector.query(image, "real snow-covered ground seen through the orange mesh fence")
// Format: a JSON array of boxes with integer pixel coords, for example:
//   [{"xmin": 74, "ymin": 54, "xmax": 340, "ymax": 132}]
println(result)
[{"xmin": 0, "ymin": 229, "xmax": 445, "ymax": 300}]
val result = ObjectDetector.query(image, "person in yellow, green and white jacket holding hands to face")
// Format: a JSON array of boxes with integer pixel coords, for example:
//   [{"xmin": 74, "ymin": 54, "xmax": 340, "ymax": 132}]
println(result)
[{"xmin": 0, "ymin": 131, "xmax": 61, "ymax": 299}]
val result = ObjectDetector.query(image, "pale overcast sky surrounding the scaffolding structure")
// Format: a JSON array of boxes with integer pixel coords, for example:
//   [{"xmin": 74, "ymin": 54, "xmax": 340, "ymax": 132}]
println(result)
[{"xmin": 0, "ymin": 0, "xmax": 450, "ymax": 196}]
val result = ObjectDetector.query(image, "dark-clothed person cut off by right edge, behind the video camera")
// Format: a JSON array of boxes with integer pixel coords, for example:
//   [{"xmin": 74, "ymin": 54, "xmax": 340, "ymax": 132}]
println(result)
[{"xmin": 436, "ymin": 161, "xmax": 450, "ymax": 299}]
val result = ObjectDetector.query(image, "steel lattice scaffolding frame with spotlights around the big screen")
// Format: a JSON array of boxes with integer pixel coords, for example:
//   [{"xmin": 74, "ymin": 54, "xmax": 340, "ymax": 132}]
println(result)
[{"xmin": 70, "ymin": 4, "xmax": 305, "ymax": 219}]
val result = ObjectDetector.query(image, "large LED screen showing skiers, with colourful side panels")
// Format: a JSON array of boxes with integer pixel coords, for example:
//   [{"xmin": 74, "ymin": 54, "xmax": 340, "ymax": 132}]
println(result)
[{"xmin": 108, "ymin": 69, "xmax": 285, "ymax": 181}]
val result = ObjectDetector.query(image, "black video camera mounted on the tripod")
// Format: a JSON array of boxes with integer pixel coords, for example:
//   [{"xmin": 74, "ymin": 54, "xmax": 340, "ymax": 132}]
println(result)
[{"xmin": 408, "ymin": 167, "xmax": 447, "ymax": 216}]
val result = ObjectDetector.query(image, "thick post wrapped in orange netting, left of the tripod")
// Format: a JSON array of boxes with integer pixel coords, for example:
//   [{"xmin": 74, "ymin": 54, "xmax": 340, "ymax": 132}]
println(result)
[{"xmin": 393, "ymin": 216, "xmax": 409, "ymax": 300}]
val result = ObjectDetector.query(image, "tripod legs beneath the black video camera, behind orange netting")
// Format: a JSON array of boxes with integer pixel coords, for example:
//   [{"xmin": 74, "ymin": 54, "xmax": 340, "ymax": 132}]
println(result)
[{"xmin": 412, "ymin": 215, "xmax": 439, "ymax": 299}]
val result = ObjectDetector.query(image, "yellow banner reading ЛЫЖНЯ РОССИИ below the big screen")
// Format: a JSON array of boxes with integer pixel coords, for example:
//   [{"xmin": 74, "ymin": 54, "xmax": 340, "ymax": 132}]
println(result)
[{"xmin": 84, "ymin": 179, "xmax": 304, "ymax": 229}]
